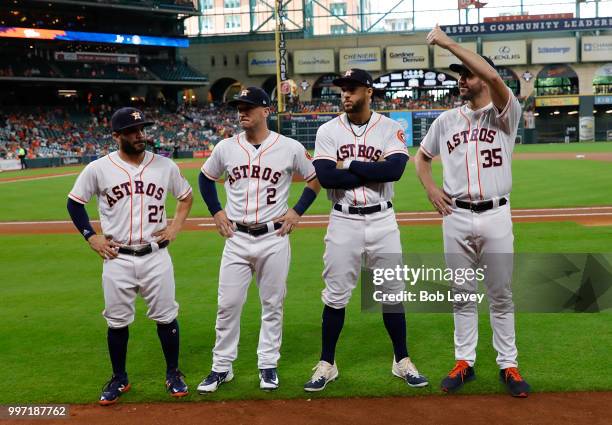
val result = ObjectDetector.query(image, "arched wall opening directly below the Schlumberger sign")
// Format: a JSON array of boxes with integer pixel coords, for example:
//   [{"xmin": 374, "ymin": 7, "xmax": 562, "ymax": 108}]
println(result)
[{"xmin": 534, "ymin": 64, "xmax": 580, "ymax": 143}]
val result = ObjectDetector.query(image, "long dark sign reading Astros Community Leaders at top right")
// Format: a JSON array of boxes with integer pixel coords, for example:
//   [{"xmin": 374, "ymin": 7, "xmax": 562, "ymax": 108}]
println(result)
[{"xmin": 442, "ymin": 17, "xmax": 612, "ymax": 35}]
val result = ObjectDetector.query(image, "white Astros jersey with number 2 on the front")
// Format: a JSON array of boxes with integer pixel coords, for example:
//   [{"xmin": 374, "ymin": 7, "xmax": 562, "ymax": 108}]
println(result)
[{"xmin": 202, "ymin": 131, "xmax": 316, "ymax": 225}]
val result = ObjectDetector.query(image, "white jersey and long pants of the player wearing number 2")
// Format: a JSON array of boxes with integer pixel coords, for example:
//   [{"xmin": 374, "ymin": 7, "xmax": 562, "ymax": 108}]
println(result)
[{"xmin": 202, "ymin": 131, "xmax": 316, "ymax": 372}]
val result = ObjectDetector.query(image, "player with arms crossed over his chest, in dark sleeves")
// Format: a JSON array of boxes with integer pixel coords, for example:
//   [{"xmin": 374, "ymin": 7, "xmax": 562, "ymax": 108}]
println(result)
[{"xmin": 304, "ymin": 69, "xmax": 428, "ymax": 391}]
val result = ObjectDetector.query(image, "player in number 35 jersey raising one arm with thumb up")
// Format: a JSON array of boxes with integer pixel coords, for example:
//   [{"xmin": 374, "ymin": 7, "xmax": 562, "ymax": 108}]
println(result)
[{"xmin": 416, "ymin": 25, "xmax": 529, "ymax": 397}]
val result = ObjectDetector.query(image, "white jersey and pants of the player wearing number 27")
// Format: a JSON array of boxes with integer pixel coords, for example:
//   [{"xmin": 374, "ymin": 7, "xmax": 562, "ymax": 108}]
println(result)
[{"xmin": 68, "ymin": 152, "xmax": 191, "ymax": 328}]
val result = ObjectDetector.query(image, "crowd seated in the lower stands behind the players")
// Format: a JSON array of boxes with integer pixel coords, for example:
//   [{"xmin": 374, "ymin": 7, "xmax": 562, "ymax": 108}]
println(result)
[{"xmin": 0, "ymin": 95, "xmax": 458, "ymax": 159}]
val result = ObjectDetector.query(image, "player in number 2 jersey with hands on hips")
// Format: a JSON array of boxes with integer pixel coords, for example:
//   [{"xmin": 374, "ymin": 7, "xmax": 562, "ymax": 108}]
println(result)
[{"xmin": 198, "ymin": 87, "xmax": 321, "ymax": 393}]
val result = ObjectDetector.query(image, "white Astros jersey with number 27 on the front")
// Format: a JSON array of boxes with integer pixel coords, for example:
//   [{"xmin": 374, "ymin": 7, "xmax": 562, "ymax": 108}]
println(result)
[{"xmin": 68, "ymin": 152, "xmax": 191, "ymax": 245}]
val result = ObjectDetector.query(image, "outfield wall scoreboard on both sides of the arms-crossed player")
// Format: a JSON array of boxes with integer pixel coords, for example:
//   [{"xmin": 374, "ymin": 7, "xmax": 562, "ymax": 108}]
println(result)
[{"xmin": 268, "ymin": 109, "xmax": 444, "ymax": 149}]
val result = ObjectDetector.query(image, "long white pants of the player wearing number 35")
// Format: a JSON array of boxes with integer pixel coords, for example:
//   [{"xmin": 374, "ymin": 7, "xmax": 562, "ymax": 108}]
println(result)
[{"xmin": 443, "ymin": 204, "xmax": 517, "ymax": 369}]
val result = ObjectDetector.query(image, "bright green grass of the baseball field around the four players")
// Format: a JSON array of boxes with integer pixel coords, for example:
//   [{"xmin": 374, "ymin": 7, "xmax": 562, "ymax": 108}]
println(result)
[{"xmin": 0, "ymin": 144, "xmax": 612, "ymax": 404}]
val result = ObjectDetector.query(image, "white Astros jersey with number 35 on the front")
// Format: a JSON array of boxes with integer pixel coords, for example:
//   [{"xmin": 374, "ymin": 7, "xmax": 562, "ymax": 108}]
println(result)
[{"xmin": 421, "ymin": 89, "xmax": 521, "ymax": 201}]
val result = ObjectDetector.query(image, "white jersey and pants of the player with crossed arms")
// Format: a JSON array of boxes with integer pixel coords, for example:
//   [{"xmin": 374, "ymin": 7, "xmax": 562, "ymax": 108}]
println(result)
[{"xmin": 314, "ymin": 112, "xmax": 408, "ymax": 309}]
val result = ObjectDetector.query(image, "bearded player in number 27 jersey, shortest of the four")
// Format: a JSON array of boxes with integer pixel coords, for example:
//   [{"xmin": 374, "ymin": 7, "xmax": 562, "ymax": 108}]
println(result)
[{"xmin": 68, "ymin": 108, "xmax": 192, "ymax": 406}]
